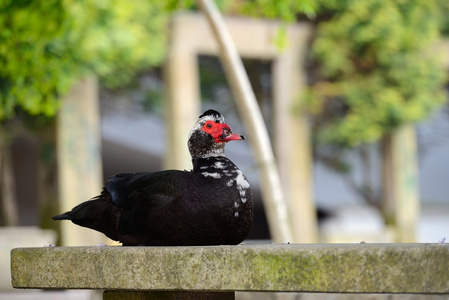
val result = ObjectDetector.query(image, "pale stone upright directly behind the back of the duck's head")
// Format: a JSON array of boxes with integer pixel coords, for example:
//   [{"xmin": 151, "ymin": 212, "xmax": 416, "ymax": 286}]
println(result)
[{"xmin": 164, "ymin": 19, "xmax": 201, "ymax": 170}]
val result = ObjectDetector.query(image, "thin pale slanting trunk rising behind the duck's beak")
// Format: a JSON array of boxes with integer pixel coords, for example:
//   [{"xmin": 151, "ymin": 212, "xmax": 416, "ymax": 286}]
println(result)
[{"xmin": 196, "ymin": 0, "xmax": 294, "ymax": 242}]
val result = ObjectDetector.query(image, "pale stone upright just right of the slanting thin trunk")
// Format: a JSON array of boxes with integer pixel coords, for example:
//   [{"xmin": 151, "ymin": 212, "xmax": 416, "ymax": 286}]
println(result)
[{"xmin": 273, "ymin": 25, "xmax": 318, "ymax": 243}]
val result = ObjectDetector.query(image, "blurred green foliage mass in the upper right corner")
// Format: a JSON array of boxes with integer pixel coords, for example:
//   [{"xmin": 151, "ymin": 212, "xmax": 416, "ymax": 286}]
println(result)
[{"xmin": 308, "ymin": 0, "xmax": 446, "ymax": 147}]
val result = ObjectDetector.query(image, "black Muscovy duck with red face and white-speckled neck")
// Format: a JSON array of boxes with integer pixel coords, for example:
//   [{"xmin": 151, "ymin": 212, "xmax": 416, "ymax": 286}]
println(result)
[{"xmin": 53, "ymin": 109, "xmax": 253, "ymax": 246}]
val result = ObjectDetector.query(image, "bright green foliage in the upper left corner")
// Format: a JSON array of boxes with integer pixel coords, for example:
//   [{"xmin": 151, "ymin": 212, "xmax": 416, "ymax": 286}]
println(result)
[{"xmin": 0, "ymin": 0, "xmax": 168, "ymax": 120}]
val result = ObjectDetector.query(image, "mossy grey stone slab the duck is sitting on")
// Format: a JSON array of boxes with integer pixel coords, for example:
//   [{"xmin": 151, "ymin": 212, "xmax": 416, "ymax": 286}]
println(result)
[{"xmin": 11, "ymin": 244, "xmax": 449, "ymax": 294}]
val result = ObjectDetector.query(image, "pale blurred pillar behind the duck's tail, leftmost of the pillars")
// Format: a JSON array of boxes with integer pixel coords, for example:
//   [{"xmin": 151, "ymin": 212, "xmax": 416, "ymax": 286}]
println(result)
[{"xmin": 57, "ymin": 77, "xmax": 106, "ymax": 246}]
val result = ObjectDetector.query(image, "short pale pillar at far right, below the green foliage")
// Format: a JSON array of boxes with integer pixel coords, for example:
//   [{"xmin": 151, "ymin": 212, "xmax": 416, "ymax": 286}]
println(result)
[{"xmin": 382, "ymin": 125, "xmax": 419, "ymax": 243}]
